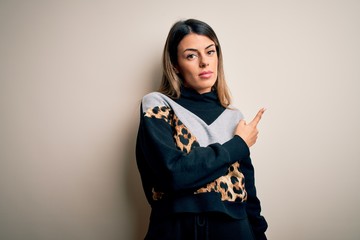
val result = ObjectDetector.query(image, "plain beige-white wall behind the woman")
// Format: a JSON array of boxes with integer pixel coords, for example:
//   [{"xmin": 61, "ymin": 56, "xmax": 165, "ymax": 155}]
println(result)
[{"xmin": 0, "ymin": 0, "xmax": 360, "ymax": 240}]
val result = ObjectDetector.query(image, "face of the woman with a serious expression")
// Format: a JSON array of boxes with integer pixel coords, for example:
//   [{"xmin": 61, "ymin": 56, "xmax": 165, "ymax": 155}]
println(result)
[{"xmin": 176, "ymin": 33, "xmax": 218, "ymax": 94}]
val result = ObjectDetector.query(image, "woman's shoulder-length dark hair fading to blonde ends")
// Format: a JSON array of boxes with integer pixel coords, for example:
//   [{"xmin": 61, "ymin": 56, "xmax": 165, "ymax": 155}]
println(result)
[{"xmin": 159, "ymin": 19, "xmax": 231, "ymax": 108}]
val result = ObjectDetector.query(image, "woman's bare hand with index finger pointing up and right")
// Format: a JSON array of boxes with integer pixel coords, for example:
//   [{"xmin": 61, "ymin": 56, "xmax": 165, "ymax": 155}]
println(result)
[{"xmin": 234, "ymin": 108, "xmax": 265, "ymax": 147}]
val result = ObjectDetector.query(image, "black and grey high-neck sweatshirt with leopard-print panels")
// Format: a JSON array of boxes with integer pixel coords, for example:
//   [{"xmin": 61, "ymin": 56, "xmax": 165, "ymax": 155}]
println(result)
[{"xmin": 136, "ymin": 88, "xmax": 267, "ymax": 239}]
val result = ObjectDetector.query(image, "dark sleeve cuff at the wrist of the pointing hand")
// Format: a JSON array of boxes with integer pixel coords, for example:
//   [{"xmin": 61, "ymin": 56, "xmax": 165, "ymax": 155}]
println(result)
[{"xmin": 223, "ymin": 135, "xmax": 250, "ymax": 163}]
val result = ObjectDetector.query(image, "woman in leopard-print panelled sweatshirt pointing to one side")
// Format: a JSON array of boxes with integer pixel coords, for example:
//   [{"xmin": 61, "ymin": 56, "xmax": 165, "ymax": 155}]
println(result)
[{"xmin": 136, "ymin": 19, "xmax": 267, "ymax": 240}]
